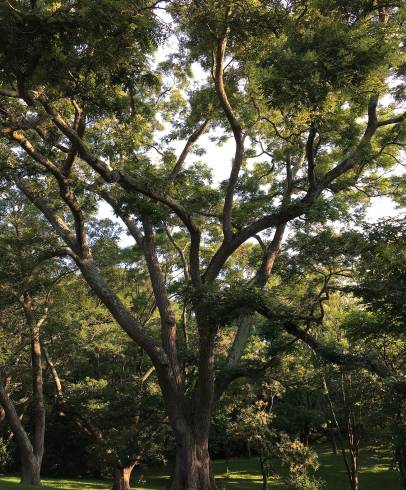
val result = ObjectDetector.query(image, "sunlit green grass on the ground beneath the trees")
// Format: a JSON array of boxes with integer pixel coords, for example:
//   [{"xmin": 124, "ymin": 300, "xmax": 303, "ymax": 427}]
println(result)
[{"xmin": 0, "ymin": 448, "xmax": 401, "ymax": 490}]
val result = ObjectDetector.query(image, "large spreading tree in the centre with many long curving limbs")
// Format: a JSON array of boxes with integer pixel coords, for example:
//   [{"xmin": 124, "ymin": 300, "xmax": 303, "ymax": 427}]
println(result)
[{"xmin": 0, "ymin": 0, "xmax": 405, "ymax": 490}]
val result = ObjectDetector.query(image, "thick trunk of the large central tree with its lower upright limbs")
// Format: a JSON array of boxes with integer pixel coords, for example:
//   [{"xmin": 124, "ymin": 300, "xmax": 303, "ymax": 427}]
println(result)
[{"xmin": 77, "ymin": 235, "xmax": 217, "ymax": 490}]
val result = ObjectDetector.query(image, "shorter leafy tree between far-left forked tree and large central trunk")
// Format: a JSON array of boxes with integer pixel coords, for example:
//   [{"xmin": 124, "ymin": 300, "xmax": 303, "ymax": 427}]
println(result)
[{"xmin": 46, "ymin": 272, "xmax": 173, "ymax": 490}]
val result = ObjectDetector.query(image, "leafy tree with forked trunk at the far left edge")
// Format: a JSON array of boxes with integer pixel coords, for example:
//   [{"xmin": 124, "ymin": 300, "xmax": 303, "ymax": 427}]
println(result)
[{"xmin": 0, "ymin": 189, "xmax": 69, "ymax": 485}]
